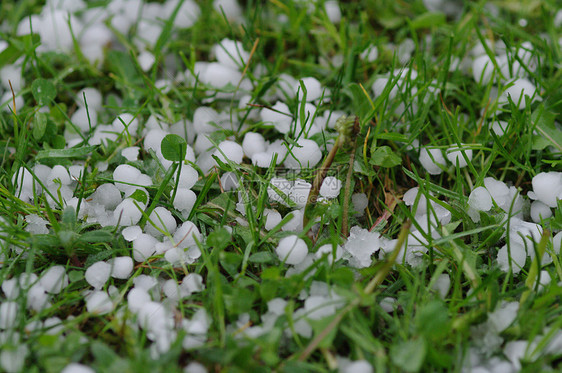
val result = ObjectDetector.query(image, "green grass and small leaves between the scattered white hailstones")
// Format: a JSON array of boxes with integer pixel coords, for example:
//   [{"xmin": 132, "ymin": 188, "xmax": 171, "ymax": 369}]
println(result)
[{"xmin": 0, "ymin": 0, "xmax": 562, "ymax": 372}]
